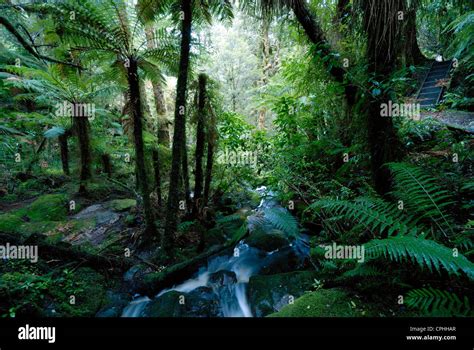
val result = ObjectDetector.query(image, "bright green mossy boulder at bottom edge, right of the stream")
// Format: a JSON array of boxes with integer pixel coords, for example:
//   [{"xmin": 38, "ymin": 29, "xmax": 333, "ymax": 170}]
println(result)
[{"xmin": 269, "ymin": 289, "xmax": 372, "ymax": 317}]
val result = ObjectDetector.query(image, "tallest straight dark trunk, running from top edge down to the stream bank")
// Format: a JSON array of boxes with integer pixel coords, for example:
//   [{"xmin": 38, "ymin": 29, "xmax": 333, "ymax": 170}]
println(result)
[{"xmin": 162, "ymin": 0, "xmax": 192, "ymax": 253}]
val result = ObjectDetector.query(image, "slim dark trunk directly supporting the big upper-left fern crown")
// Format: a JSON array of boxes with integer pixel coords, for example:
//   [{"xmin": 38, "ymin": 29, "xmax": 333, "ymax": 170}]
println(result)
[{"xmin": 127, "ymin": 57, "xmax": 156, "ymax": 238}]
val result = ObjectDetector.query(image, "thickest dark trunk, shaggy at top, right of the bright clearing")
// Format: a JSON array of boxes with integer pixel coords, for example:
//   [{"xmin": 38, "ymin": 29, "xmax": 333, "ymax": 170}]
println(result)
[{"xmin": 363, "ymin": 0, "xmax": 404, "ymax": 195}]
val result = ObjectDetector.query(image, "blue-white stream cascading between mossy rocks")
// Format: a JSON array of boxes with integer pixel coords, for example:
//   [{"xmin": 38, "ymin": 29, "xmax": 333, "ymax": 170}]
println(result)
[{"xmin": 122, "ymin": 187, "xmax": 308, "ymax": 317}]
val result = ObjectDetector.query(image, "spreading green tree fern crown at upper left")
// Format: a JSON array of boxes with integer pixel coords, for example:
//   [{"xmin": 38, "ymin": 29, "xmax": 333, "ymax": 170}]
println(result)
[{"xmin": 31, "ymin": 0, "xmax": 179, "ymax": 84}]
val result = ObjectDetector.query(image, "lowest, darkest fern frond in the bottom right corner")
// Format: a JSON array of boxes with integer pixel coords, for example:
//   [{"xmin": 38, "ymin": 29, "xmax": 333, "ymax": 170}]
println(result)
[{"xmin": 405, "ymin": 288, "xmax": 472, "ymax": 316}]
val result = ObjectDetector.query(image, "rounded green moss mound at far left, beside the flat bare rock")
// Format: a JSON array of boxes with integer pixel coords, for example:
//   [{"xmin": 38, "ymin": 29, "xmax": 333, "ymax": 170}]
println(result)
[{"xmin": 26, "ymin": 194, "xmax": 68, "ymax": 221}]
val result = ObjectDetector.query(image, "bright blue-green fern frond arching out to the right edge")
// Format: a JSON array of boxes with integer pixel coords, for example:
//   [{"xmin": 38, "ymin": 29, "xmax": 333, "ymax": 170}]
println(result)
[{"xmin": 365, "ymin": 236, "xmax": 474, "ymax": 279}]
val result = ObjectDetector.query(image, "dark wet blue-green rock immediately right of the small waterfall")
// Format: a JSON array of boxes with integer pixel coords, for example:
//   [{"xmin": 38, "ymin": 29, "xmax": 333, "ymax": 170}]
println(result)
[{"xmin": 247, "ymin": 271, "xmax": 316, "ymax": 317}]
